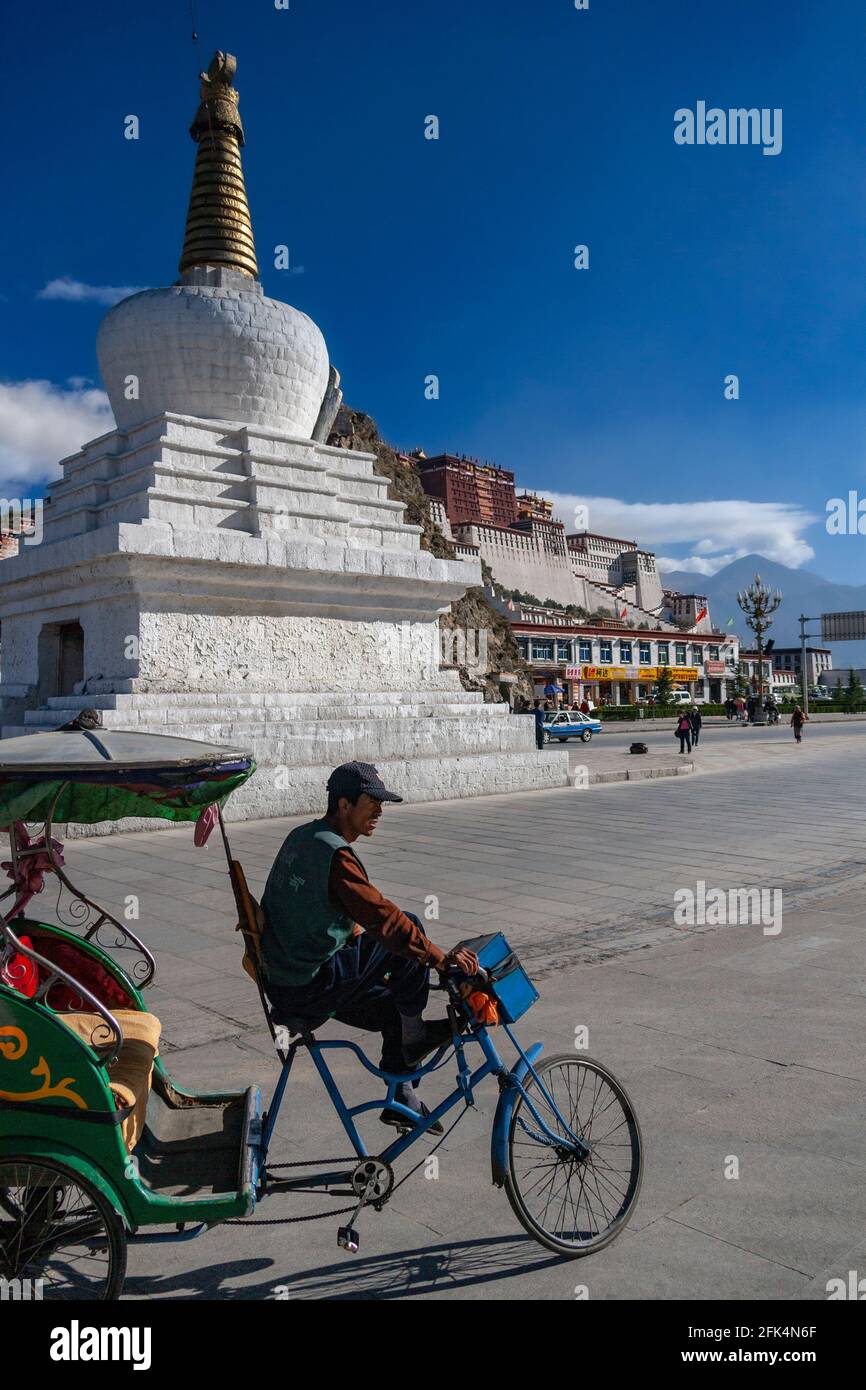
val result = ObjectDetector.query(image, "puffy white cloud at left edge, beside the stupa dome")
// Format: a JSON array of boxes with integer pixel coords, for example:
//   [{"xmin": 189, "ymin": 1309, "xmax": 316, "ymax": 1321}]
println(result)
[{"xmin": 0, "ymin": 381, "xmax": 114, "ymax": 484}]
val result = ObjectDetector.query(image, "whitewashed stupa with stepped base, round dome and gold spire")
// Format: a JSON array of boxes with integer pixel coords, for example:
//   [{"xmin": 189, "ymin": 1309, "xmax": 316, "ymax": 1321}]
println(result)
[{"xmin": 0, "ymin": 53, "xmax": 567, "ymax": 817}]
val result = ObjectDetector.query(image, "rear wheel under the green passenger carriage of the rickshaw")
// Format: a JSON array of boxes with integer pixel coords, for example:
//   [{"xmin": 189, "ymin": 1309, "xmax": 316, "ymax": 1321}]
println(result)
[{"xmin": 0, "ymin": 1158, "xmax": 126, "ymax": 1300}]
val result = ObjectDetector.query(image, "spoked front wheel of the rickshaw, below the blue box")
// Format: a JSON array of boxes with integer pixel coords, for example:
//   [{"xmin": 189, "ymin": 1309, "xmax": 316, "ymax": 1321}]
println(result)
[{"xmin": 505, "ymin": 1055, "xmax": 642, "ymax": 1257}]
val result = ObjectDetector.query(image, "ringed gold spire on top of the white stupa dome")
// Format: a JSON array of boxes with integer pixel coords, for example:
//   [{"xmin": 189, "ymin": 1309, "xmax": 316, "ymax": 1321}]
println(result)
[{"xmin": 179, "ymin": 53, "xmax": 259, "ymax": 277}]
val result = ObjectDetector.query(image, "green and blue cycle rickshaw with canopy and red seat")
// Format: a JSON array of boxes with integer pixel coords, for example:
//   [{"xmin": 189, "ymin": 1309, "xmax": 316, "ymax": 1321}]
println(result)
[{"xmin": 0, "ymin": 728, "xmax": 641, "ymax": 1300}]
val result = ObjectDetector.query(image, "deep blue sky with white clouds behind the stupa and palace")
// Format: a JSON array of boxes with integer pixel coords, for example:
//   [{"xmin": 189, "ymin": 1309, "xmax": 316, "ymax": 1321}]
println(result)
[{"xmin": 0, "ymin": 0, "xmax": 866, "ymax": 582}]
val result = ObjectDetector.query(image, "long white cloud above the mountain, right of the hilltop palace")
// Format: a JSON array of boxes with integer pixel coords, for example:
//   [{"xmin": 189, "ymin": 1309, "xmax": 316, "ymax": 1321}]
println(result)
[{"xmin": 550, "ymin": 492, "xmax": 822, "ymax": 575}]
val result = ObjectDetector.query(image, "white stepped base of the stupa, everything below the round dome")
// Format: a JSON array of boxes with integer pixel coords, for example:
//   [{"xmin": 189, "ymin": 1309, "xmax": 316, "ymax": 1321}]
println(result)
[{"xmin": 0, "ymin": 413, "xmax": 569, "ymax": 819}]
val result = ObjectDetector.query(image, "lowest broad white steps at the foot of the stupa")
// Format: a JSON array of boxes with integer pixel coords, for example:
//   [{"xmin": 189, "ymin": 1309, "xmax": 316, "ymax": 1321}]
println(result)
[{"xmin": 3, "ymin": 689, "xmax": 569, "ymax": 833}]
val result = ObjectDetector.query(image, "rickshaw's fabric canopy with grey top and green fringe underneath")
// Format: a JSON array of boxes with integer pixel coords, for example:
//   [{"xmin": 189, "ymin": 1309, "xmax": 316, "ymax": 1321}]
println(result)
[{"xmin": 0, "ymin": 728, "xmax": 256, "ymax": 828}]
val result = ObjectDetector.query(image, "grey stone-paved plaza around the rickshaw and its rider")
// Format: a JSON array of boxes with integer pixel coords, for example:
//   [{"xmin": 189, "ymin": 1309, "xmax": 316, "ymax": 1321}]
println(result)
[{"xmin": 25, "ymin": 728, "xmax": 866, "ymax": 1300}]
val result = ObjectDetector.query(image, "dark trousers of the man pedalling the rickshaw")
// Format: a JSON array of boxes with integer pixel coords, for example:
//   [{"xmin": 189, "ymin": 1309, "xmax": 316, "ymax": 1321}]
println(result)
[{"xmin": 267, "ymin": 913, "xmax": 430, "ymax": 1072}]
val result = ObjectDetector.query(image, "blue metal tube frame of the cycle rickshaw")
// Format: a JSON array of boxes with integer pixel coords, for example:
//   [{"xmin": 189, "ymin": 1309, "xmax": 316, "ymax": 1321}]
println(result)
[{"xmin": 260, "ymin": 1024, "xmax": 589, "ymax": 1191}]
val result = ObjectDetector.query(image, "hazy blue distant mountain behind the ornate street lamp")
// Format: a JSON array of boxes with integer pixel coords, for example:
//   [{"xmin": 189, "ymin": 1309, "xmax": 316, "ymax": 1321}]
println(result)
[{"xmin": 662, "ymin": 555, "xmax": 866, "ymax": 667}]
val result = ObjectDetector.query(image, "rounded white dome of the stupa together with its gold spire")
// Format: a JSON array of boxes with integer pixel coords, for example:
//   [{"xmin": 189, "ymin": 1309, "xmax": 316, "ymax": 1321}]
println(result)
[{"xmin": 96, "ymin": 53, "xmax": 329, "ymax": 439}]
